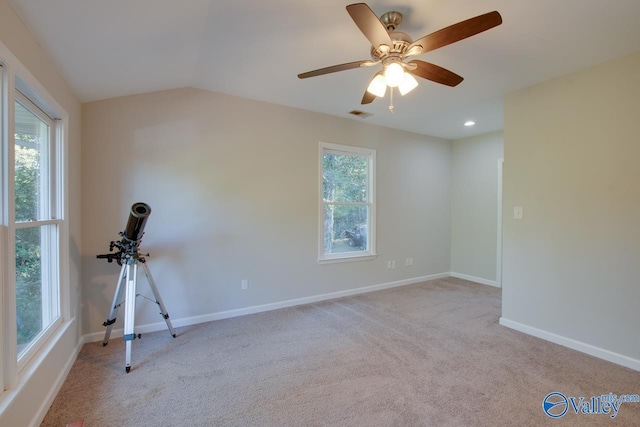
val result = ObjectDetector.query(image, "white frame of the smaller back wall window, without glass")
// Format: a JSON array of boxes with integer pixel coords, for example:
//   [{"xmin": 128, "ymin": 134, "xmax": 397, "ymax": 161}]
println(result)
[{"xmin": 318, "ymin": 142, "xmax": 377, "ymax": 264}]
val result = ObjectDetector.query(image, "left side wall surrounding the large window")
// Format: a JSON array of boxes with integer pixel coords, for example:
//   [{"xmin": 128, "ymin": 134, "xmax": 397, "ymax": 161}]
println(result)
[{"xmin": 0, "ymin": 0, "xmax": 81, "ymax": 426}]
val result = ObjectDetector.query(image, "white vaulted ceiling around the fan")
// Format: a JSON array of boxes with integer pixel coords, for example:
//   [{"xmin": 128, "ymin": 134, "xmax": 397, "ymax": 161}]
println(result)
[{"xmin": 9, "ymin": 0, "xmax": 640, "ymax": 139}]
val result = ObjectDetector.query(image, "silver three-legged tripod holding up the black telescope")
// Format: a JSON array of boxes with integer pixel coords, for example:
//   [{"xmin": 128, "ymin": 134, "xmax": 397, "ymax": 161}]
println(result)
[{"xmin": 102, "ymin": 253, "xmax": 176, "ymax": 373}]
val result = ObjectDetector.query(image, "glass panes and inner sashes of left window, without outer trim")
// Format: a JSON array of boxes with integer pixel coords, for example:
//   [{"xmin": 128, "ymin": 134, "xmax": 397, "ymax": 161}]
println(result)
[{"xmin": 13, "ymin": 91, "xmax": 61, "ymax": 360}]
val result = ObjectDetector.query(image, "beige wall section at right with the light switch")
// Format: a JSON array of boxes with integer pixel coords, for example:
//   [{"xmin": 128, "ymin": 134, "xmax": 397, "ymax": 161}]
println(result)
[{"xmin": 503, "ymin": 53, "xmax": 640, "ymax": 369}]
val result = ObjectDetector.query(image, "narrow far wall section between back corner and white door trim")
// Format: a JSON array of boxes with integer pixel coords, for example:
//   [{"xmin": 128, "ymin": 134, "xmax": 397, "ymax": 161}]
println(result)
[{"xmin": 451, "ymin": 131, "xmax": 503, "ymax": 286}]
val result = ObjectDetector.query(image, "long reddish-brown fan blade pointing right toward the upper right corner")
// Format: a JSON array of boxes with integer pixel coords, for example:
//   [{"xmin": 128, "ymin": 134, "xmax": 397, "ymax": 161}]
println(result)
[{"xmin": 407, "ymin": 11, "xmax": 502, "ymax": 55}]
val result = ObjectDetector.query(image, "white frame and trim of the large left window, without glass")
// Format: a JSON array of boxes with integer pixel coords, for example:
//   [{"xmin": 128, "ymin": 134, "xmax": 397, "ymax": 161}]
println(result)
[{"xmin": 0, "ymin": 42, "xmax": 71, "ymax": 394}]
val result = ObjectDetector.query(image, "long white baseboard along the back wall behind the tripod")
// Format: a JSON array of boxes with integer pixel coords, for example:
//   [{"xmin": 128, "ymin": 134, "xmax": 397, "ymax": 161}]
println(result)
[{"xmin": 83, "ymin": 272, "xmax": 450, "ymax": 342}]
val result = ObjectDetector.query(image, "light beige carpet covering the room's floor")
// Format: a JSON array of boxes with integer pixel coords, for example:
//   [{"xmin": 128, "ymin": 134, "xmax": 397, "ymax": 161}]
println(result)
[{"xmin": 42, "ymin": 278, "xmax": 640, "ymax": 427}]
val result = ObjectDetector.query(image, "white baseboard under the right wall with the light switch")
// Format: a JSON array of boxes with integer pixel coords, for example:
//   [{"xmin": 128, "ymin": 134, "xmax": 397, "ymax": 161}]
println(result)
[{"xmin": 500, "ymin": 317, "xmax": 640, "ymax": 371}]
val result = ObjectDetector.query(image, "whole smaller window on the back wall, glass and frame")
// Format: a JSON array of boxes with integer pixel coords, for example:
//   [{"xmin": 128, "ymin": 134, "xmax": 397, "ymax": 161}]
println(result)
[{"xmin": 318, "ymin": 143, "xmax": 376, "ymax": 262}]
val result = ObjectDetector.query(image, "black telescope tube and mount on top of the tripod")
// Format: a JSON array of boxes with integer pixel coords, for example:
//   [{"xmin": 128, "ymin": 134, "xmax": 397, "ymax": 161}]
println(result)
[{"xmin": 96, "ymin": 202, "xmax": 151, "ymax": 265}]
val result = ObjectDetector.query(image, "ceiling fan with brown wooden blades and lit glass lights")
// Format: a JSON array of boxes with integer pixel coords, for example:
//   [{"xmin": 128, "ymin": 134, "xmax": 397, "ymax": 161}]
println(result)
[{"xmin": 298, "ymin": 3, "xmax": 502, "ymax": 111}]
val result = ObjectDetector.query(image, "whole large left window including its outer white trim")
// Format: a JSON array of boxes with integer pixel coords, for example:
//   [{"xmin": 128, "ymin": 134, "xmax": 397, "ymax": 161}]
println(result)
[{"xmin": 0, "ymin": 43, "xmax": 70, "ymax": 393}]
